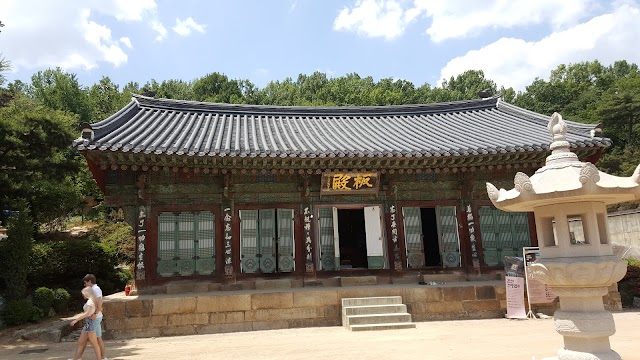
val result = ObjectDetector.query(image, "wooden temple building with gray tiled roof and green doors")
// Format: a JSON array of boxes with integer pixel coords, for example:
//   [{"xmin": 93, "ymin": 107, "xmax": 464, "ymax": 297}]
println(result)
[{"xmin": 74, "ymin": 95, "xmax": 610, "ymax": 289}]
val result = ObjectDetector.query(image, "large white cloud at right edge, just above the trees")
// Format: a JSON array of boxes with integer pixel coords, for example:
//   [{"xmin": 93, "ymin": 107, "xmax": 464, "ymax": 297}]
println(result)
[{"xmin": 440, "ymin": 2, "xmax": 640, "ymax": 90}]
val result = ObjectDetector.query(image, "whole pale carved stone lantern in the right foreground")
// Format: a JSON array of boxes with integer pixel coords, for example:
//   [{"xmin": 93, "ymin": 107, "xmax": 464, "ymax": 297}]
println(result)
[{"xmin": 487, "ymin": 113, "xmax": 640, "ymax": 360}]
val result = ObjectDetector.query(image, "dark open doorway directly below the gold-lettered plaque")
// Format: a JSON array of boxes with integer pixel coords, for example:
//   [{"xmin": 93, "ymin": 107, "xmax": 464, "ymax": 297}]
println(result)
[{"xmin": 338, "ymin": 209, "xmax": 368, "ymax": 268}]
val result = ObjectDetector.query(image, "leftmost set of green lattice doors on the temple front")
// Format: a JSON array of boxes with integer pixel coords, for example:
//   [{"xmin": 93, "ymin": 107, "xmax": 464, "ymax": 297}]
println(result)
[{"xmin": 158, "ymin": 212, "xmax": 215, "ymax": 277}]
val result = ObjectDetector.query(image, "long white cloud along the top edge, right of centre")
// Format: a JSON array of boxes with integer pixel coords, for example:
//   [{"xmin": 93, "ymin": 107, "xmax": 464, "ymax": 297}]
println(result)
[{"xmin": 333, "ymin": 0, "xmax": 595, "ymax": 42}]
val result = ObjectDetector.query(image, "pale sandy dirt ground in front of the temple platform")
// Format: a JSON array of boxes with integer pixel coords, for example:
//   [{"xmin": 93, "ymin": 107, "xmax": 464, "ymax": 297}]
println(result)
[{"xmin": 0, "ymin": 311, "xmax": 640, "ymax": 360}]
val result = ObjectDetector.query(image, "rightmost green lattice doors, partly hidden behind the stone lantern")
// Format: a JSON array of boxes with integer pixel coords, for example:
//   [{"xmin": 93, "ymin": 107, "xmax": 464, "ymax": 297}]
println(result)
[{"xmin": 478, "ymin": 206, "xmax": 531, "ymax": 266}]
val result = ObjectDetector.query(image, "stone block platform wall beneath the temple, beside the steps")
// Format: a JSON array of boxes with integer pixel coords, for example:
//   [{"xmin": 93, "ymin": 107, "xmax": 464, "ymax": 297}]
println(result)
[{"xmin": 104, "ymin": 281, "xmax": 506, "ymax": 339}]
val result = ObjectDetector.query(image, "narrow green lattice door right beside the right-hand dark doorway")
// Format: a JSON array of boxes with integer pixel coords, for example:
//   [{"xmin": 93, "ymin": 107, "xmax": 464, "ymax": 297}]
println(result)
[{"xmin": 436, "ymin": 206, "xmax": 460, "ymax": 267}]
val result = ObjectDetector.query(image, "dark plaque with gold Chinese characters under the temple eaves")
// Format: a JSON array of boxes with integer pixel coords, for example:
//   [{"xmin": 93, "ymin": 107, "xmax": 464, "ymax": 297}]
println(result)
[{"xmin": 320, "ymin": 172, "xmax": 379, "ymax": 195}]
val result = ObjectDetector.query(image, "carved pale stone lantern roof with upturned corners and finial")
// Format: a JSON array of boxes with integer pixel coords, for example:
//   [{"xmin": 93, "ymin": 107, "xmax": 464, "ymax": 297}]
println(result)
[{"xmin": 487, "ymin": 113, "xmax": 640, "ymax": 212}]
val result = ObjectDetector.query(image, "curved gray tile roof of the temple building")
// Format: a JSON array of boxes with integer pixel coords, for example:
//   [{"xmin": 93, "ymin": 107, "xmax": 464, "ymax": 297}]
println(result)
[{"xmin": 74, "ymin": 95, "xmax": 610, "ymax": 157}]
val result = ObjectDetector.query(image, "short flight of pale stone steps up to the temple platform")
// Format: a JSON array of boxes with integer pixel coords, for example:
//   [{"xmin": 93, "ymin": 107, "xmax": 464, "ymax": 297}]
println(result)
[{"xmin": 342, "ymin": 296, "xmax": 416, "ymax": 331}]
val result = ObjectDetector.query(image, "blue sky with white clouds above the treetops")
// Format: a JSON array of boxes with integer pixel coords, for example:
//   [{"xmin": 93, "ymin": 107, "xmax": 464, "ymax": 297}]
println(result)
[{"xmin": 0, "ymin": 0, "xmax": 640, "ymax": 90}]
